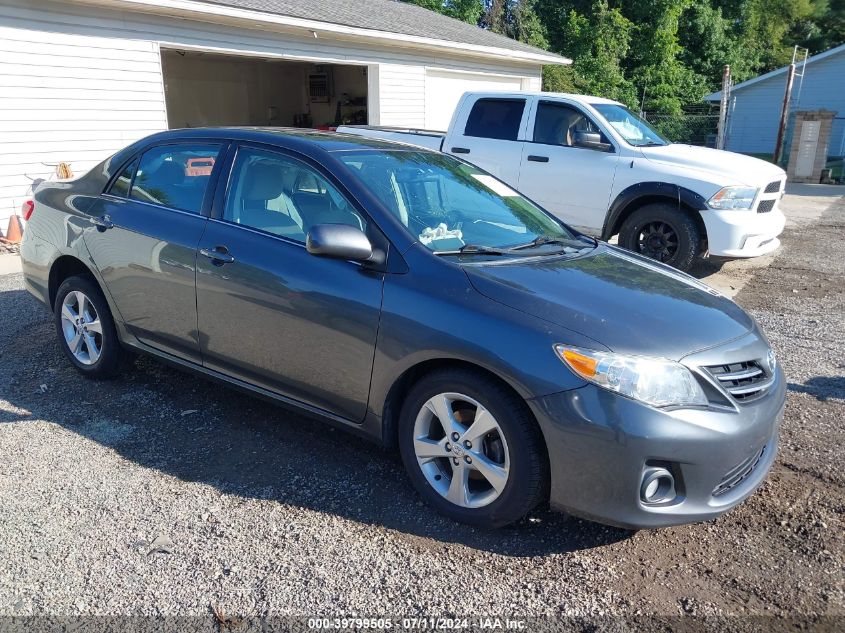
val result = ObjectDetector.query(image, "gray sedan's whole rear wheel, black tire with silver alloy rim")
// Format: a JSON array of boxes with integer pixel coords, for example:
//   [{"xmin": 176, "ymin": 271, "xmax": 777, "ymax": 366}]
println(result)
[{"xmin": 53, "ymin": 276, "xmax": 127, "ymax": 379}]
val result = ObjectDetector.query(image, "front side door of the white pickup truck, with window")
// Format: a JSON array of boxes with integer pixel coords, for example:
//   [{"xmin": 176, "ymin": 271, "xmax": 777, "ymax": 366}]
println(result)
[{"xmin": 518, "ymin": 100, "xmax": 619, "ymax": 235}]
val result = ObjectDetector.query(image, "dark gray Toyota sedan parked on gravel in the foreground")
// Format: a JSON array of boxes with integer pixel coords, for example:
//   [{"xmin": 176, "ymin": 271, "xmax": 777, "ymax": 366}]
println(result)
[{"xmin": 21, "ymin": 129, "xmax": 785, "ymax": 528}]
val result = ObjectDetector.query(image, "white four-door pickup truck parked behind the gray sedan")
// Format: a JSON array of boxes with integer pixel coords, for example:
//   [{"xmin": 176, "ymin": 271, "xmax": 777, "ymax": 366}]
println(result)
[{"xmin": 338, "ymin": 92, "xmax": 786, "ymax": 270}]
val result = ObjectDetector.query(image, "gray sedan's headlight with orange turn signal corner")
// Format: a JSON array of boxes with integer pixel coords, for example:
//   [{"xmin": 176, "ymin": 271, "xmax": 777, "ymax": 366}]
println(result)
[{"xmin": 555, "ymin": 345, "xmax": 707, "ymax": 407}]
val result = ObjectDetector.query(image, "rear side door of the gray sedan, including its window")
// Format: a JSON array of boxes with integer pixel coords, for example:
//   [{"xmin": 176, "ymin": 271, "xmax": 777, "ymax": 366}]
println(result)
[{"xmin": 84, "ymin": 141, "xmax": 223, "ymax": 363}]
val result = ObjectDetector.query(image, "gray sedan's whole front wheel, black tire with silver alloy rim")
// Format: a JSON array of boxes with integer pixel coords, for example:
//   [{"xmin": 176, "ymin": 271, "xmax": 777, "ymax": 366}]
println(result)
[{"xmin": 399, "ymin": 369, "xmax": 549, "ymax": 528}]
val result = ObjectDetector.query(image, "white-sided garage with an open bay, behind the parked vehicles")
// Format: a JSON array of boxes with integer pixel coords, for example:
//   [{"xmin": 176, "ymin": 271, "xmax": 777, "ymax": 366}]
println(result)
[{"xmin": 0, "ymin": 0, "xmax": 569, "ymax": 230}]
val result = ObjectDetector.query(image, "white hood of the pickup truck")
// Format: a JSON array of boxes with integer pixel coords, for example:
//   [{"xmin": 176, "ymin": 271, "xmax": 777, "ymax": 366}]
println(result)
[{"xmin": 640, "ymin": 143, "xmax": 785, "ymax": 187}]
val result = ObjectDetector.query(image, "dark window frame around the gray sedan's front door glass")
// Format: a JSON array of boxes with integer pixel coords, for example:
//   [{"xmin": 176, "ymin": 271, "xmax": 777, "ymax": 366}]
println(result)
[{"xmin": 209, "ymin": 141, "xmax": 378, "ymax": 249}]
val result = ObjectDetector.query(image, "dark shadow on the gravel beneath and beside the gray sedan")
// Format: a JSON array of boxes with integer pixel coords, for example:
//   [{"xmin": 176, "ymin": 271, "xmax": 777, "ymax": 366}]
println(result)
[{"xmin": 0, "ymin": 292, "xmax": 632, "ymax": 557}]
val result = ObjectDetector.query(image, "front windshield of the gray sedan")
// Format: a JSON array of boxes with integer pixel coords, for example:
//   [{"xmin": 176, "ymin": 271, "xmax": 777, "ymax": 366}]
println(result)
[{"xmin": 338, "ymin": 150, "xmax": 585, "ymax": 254}]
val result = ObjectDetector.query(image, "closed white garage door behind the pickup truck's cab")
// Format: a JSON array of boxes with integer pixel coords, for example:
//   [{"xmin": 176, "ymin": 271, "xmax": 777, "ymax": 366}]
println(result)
[{"xmin": 425, "ymin": 69, "xmax": 522, "ymax": 131}]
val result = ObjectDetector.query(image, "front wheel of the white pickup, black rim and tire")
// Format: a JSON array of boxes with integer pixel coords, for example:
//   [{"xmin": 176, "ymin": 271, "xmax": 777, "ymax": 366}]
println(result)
[{"xmin": 619, "ymin": 204, "xmax": 701, "ymax": 271}]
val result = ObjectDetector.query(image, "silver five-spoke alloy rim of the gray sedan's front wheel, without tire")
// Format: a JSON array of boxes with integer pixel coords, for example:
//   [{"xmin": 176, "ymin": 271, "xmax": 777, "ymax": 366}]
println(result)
[{"xmin": 414, "ymin": 393, "xmax": 510, "ymax": 508}]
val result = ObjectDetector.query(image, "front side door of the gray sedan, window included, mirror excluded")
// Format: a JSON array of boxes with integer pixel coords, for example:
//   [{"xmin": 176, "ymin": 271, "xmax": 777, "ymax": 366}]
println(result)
[{"xmin": 197, "ymin": 146, "xmax": 384, "ymax": 421}]
